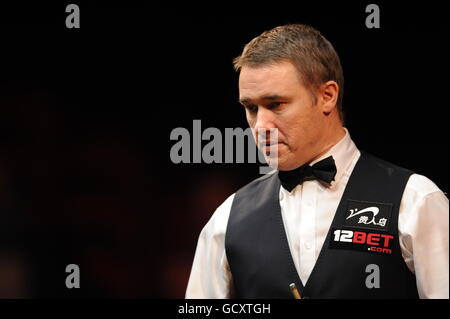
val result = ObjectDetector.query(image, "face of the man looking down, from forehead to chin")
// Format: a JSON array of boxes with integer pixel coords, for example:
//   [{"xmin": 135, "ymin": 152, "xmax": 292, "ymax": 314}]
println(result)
[{"xmin": 239, "ymin": 61, "xmax": 326, "ymax": 170}]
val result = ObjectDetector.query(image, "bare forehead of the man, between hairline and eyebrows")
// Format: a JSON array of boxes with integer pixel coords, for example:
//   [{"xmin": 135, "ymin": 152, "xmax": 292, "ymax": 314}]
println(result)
[{"xmin": 239, "ymin": 61, "xmax": 301, "ymax": 100}]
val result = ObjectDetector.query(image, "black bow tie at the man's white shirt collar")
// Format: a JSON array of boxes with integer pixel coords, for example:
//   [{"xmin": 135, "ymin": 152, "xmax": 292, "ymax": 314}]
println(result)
[{"xmin": 278, "ymin": 156, "xmax": 336, "ymax": 191}]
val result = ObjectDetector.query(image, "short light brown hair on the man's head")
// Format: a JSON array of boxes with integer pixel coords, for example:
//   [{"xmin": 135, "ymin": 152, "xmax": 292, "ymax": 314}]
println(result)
[{"xmin": 233, "ymin": 24, "xmax": 344, "ymax": 122}]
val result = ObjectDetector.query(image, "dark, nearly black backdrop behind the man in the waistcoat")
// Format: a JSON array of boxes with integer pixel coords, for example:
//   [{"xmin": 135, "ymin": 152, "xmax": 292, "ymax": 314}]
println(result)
[{"xmin": 0, "ymin": 1, "xmax": 448, "ymax": 298}]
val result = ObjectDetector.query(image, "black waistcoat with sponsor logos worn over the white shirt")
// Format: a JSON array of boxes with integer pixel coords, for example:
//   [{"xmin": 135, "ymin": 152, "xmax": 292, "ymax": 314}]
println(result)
[{"xmin": 225, "ymin": 153, "xmax": 418, "ymax": 298}]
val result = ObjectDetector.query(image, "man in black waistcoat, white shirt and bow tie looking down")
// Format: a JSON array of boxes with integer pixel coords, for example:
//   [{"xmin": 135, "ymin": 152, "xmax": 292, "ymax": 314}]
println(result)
[{"xmin": 186, "ymin": 25, "xmax": 449, "ymax": 298}]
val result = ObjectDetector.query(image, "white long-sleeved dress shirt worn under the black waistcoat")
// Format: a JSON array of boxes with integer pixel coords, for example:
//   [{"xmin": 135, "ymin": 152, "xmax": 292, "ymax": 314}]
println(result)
[{"xmin": 186, "ymin": 129, "xmax": 449, "ymax": 298}]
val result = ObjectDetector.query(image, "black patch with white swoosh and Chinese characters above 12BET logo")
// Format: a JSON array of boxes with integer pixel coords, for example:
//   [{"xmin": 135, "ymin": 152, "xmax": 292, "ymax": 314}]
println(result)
[{"xmin": 344, "ymin": 199, "xmax": 392, "ymax": 231}]
